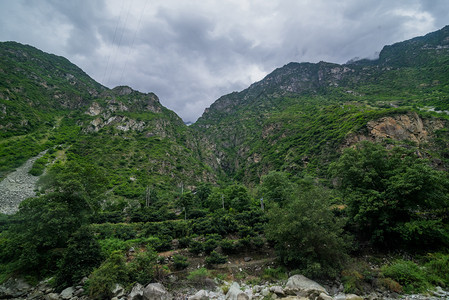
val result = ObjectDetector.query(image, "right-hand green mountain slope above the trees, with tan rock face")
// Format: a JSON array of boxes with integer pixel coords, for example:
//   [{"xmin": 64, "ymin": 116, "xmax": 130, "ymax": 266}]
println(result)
[{"xmin": 192, "ymin": 26, "xmax": 449, "ymax": 182}]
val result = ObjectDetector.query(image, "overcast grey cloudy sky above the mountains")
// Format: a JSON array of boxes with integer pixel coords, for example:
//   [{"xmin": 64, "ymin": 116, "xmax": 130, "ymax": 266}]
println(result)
[{"xmin": 0, "ymin": 0, "xmax": 449, "ymax": 121}]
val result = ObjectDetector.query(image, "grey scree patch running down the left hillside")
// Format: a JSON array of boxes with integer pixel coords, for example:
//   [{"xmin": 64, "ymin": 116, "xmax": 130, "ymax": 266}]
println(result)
[{"xmin": 0, "ymin": 151, "xmax": 45, "ymax": 214}]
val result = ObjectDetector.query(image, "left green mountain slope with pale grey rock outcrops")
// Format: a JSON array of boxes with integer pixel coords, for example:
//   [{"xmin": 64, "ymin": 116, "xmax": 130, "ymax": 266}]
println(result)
[{"xmin": 0, "ymin": 42, "xmax": 216, "ymax": 206}]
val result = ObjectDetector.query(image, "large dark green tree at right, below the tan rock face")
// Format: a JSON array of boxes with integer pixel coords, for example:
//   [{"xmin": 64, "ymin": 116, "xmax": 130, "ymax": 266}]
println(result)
[{"xmin": 330, "ymin": 142, "xmax": 449, "ymax": 247}]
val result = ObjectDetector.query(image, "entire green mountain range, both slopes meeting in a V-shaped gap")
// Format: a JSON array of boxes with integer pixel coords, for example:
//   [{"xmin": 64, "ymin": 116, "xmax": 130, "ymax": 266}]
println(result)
[{"xmin": 0, "ymin": 26, "xmax": 449, "ymax": 199}]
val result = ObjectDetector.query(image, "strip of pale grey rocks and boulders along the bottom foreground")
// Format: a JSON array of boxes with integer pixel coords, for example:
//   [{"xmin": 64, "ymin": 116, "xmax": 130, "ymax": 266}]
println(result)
[{"xmin": 0, "ymin": 275, "xmax": 449, "ymax": 300}]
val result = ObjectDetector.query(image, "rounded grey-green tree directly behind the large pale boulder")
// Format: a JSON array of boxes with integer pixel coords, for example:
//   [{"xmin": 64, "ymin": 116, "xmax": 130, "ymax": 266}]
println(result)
[{"xmin": 266, "ymin": 187, "xmax": 350, "ymax": 277}]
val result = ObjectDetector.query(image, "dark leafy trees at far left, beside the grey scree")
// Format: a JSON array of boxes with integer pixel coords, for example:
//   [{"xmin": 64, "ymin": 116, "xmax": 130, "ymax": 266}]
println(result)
[{"xmin": 0, "ymin": 162, "xmax": 105, "ymax": 278}]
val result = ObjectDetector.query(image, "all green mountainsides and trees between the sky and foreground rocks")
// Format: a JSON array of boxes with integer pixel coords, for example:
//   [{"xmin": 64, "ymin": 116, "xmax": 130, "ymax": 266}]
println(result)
[{"xmin": 0, "ymin": 26, "xmax": 449, "ymax": 299}]
